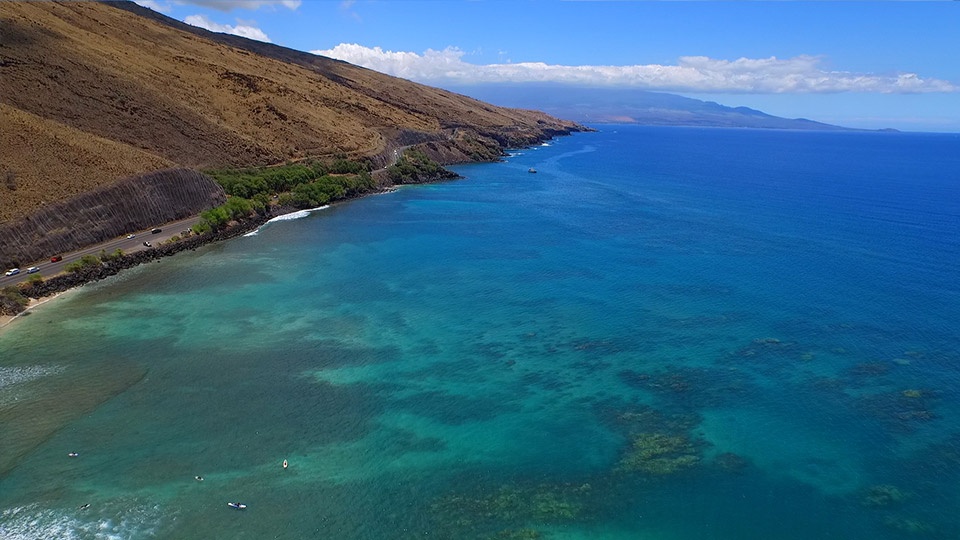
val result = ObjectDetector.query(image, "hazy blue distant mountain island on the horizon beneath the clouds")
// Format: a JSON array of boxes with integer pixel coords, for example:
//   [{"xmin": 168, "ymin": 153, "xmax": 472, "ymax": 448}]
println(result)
[{"xmin": 448, "ymin": 84, "xmax": 876, "ymax": 131}]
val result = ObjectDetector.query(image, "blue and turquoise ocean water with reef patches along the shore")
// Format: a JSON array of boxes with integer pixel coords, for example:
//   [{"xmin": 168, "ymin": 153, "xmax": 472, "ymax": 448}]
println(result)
[{"xmin": 0, "ymin": 126, "xmax": 960, "ymax": 540}]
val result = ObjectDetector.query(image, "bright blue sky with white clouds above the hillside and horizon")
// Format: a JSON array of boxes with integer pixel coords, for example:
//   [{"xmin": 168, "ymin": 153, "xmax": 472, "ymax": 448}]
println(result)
[{"xmin": 136, "ymin": 0, "xmax": 960, "ymax": 132}]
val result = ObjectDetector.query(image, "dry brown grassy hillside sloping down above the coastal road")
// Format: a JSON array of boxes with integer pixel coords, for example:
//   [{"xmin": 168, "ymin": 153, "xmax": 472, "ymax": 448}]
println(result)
[{"xmin": 0, "ymin": 2, "xmax": 577, "ymax": 221}]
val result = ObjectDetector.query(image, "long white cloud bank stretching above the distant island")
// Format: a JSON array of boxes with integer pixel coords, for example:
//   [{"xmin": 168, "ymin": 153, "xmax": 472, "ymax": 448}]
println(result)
[{"xmin": 311, "ymin": 43, "xmax": 960, "ymax": 94}]
